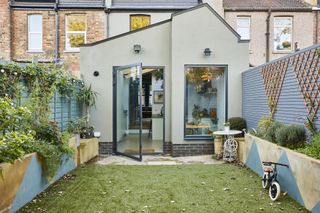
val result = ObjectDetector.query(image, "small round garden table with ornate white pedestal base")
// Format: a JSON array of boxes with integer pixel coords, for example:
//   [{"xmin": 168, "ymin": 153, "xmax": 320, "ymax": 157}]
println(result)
[{"xmin": 213, "ymin": 130, "xmax": 242, "ymax": 162}]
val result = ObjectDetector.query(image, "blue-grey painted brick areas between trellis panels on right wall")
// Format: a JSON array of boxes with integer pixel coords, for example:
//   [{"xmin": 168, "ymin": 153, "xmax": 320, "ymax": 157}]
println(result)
[{"xmin": 242, "ymin": 45, "xmax": 320, "ymax": 128}]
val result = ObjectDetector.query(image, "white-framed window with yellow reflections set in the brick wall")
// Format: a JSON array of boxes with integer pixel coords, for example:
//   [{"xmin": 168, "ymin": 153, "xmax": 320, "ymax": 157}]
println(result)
[{"xmin": 66, "ymin": 15, "xmax": 87, "ymax": 51}]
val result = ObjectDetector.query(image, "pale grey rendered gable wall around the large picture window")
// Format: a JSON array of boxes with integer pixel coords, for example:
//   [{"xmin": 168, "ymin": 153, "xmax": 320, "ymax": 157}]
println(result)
[{"xmin": 171, "ymin": 6, "xmax": 249, "ymax": 144}]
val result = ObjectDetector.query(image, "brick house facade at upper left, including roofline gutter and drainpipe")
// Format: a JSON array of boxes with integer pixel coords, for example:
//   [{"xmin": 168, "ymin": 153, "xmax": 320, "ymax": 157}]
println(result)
[{"xmin": 7, "ymin": 0, "xmax": 106, "ymax": 77}]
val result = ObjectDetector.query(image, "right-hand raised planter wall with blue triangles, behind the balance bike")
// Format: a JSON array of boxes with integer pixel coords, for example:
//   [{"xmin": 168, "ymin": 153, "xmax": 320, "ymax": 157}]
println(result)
[{"xmin": 242, "ymin": 134, "xmax": 320, "ymax": 212}]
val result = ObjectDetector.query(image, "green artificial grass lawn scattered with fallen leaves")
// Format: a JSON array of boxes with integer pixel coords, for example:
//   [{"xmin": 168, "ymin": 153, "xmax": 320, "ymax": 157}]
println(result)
[{"xmin": 20, "ymin": 164, "xmax": 307, "ymax": 213}]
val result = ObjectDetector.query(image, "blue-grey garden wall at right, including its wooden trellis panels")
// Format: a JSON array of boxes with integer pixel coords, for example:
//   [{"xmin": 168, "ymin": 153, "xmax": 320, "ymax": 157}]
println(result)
[{"xmin": 242, "ymin": 44, "xmax": 320, "ymax": 128}]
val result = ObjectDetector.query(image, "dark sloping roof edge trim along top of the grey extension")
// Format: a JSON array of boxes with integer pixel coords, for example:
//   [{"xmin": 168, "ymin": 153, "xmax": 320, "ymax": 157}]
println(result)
[{"xmin": 80, "ymin": 3, "xmax": 249, "ymax": 47}]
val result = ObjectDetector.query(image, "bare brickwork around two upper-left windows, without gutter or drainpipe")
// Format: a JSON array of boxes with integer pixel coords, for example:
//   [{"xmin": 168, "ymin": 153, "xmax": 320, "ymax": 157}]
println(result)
[{"xmin": 12, "ymin": 10, "xmax": 106, "ymax": 76}]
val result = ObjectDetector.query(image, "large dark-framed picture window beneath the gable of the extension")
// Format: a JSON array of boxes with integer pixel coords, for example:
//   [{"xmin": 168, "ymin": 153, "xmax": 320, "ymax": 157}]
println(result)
[{"xmin": 185, "ymin": 67, "xmax": 226, "ymax": 139}]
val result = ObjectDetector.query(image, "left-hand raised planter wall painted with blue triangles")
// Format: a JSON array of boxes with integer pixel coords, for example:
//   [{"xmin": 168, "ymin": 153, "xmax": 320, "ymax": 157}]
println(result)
[{"xmin": 0, "ymin": 137, "xmax": 77, "ymax": 212}]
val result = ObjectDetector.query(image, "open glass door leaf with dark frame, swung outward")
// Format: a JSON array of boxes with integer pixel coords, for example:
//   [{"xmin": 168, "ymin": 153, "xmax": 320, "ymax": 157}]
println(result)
[{"xmin": 113, "ymin": 64, "xmax": 142, "ymax": 160}]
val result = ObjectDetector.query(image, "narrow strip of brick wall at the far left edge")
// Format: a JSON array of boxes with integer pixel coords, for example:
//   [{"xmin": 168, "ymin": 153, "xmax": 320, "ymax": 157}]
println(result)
[{"xmin": 0, "ymin": 0, "xmax": 10, "ymax": 60}]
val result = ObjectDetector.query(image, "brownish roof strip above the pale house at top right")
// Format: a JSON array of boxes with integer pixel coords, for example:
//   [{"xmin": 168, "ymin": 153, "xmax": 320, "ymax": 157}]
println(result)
[{"xmin": 223, "ymin": 0, "xmax": 312, "ymax": 11}]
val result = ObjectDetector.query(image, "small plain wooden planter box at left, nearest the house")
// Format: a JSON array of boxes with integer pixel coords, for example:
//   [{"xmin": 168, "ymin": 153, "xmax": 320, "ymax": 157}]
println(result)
[{"xmin": 78, "ymin": 138, "xmax": 99, "ymax": 164}]
